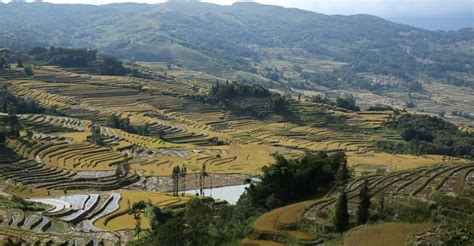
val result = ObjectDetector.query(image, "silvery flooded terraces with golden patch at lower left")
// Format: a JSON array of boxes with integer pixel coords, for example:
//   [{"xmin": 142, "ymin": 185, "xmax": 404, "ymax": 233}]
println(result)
[{"xmin": 0, "ymin": 191, "xmax": 189, "ymax": 245}]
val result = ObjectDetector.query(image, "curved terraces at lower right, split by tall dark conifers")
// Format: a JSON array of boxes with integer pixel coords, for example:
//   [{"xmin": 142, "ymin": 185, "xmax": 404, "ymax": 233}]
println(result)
[{"xmin": 248, "ymin": 163, "xmax": 474, "ymax": 245}]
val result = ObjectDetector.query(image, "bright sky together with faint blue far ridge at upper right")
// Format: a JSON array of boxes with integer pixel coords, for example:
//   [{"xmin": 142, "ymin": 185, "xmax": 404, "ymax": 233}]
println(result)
[{"xmin": 0, "ymin": 0, "xmax": 474, "ymax": 31}]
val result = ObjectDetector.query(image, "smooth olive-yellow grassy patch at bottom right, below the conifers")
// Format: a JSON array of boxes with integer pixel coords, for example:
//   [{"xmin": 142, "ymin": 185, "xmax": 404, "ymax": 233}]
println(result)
[{"xmin": 344, "ymin": 222, "xmax": 436, "ymax": 246}]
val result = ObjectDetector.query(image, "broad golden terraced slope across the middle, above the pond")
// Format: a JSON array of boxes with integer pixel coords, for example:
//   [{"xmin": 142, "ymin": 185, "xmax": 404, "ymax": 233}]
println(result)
[{"xmin": 1, "ymin": 67, "xmax": 462, "ymax": 175}]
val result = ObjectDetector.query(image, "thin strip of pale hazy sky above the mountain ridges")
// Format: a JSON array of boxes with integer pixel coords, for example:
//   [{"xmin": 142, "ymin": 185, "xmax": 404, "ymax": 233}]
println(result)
[{"xmin": 4, "ymin": 0, "xmax": 474, "ymax": 17}]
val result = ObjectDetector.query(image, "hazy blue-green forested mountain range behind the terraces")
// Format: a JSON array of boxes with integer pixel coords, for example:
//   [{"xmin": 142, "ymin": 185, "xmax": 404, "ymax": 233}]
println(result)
[{"xmin": 0, "ymin": 2, "xmax": 474, "ymax": 89}]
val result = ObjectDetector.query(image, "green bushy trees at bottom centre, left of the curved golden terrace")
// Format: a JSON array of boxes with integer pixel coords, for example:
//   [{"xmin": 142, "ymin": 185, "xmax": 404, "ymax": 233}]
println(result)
[{"xmin": 132, "ymin": 195, "xmax": 261, "ymax": 246}]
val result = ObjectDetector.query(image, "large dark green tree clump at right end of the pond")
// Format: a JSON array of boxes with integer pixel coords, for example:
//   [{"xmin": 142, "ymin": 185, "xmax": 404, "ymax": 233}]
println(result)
[{"xmin": 247, "ymin": 152, "xmax": 350, "ymax": 209}]
